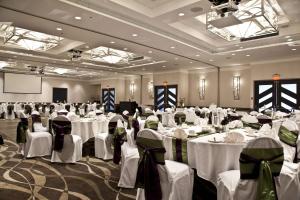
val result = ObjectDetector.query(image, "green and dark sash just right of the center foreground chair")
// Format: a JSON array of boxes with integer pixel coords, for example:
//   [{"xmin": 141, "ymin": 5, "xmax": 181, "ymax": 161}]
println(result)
[{"xmin": 172, "ymin": 138, "xmax": 188, "ymax": 164}]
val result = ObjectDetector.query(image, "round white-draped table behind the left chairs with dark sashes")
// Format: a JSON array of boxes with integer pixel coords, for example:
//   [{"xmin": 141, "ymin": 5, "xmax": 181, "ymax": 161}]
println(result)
[{"xmin": 71, "ymin": 118, "xmax": 108, "ymax": 143}]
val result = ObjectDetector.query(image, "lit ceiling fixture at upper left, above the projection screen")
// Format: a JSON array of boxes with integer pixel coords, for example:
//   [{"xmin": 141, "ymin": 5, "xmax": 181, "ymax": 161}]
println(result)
[{"xmin": 0, "ymin": 22, "xmax": 63, "ymax": 51}]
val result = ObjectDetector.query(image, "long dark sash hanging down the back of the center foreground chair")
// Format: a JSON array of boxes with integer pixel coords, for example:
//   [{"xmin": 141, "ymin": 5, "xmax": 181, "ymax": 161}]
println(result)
[{"xmin": 135, "ymin": 143, "xmax": 166, "ymax": 200}]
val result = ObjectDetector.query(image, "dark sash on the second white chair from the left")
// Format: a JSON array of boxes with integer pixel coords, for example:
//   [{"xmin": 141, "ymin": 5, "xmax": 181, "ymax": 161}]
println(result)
[{"xmin": 52, "ymin": 120, "xmax": 72, "ymax": 152}]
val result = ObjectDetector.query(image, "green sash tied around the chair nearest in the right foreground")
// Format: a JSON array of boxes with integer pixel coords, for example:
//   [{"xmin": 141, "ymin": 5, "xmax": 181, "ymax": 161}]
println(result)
[{"xmin": 240, "ymin": 148, "xmax": 284, "ymax": 200}]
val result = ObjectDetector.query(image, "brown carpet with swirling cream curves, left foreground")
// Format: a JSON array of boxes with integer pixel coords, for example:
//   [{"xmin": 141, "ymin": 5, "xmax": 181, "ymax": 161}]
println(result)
[{"xmin": 0, "ymin": 120, "xmax": 136, "ymax": 200}]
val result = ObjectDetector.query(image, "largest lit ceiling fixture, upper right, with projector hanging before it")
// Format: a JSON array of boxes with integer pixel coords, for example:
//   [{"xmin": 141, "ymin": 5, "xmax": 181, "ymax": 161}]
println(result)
[{"xmin": 206, "ymin": 0, "xmax": 279, "ymax": 41}]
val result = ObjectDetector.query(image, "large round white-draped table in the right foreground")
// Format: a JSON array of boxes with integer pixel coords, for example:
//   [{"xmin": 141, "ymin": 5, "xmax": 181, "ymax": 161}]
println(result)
[{"xmin": 162, "ymin": 126, "xmax": 253, "ymax": 185}]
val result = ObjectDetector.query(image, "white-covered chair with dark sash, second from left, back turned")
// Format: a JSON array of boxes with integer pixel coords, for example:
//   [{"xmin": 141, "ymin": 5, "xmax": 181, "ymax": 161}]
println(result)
[{"xmin": 51, "ymin": 115, "xmax": 82, "ymax": 163}]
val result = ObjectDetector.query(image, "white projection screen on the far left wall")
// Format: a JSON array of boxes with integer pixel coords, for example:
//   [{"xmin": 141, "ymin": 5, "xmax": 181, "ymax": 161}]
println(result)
[{"xmin": 3, "ymin": 73, "xmax": 42, "ymax": 94}]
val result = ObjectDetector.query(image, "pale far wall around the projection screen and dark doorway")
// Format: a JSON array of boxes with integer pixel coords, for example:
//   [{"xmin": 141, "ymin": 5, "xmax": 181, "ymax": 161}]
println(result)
[{"xmin": 0, "ymin": 73, "xmax": 97, "ymax": 103}]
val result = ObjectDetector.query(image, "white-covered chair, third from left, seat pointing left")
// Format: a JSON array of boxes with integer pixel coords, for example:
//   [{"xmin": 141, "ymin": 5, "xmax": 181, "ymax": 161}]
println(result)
[{"xmin": 95, "ymin": 115, "xmax": 124, "ymax": 160}]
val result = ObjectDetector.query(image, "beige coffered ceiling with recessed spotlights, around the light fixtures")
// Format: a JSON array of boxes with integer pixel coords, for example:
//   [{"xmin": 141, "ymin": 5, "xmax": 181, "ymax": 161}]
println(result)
[{"xmin": 0, "ymin": 0, "xmax": 300, "ymax": 80}]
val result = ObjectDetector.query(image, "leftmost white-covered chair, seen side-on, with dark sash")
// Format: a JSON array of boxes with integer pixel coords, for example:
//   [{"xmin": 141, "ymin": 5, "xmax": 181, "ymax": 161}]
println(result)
[{"xmin": 17, "ymin": 112, "xmax": 52, "ymax": 158}]
